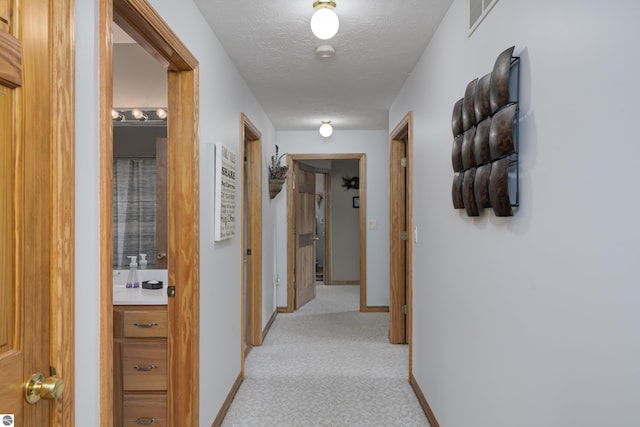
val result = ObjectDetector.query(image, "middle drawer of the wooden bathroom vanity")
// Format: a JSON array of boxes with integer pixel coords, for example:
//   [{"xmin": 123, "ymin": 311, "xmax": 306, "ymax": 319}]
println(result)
[{"xmin": 122, "ymin": 340, "xmax": 168, "ymax": 390}]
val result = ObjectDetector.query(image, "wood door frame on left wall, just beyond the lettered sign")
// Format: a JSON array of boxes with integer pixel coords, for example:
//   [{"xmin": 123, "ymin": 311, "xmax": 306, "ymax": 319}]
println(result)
[{"xmin": 240, "ymin": 113, "xmax": 262, "ymax": 366}]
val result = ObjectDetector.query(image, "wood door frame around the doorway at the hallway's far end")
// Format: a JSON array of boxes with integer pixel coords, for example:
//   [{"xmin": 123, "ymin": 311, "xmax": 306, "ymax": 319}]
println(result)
[{"xmin": 280, "ymin": 153, "xmax": 370, "ymax": 313}]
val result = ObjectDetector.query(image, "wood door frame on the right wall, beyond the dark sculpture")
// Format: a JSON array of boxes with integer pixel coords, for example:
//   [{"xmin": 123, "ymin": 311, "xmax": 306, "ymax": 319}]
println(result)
[{"xmin": 389, "ymin": 112, "xmax": 413, "ymax": 377}]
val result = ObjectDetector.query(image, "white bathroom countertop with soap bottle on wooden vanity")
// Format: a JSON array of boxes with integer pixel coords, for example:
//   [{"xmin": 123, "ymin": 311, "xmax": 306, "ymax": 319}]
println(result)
[{"xmin": 113, "ymin": 270, "xmax": 168, "ymax": 305}]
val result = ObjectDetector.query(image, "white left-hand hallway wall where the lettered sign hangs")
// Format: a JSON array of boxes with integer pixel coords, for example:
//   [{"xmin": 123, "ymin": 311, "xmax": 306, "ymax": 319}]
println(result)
[{"xmin": 76, "ymin": 0, "xmax": 275, "ymax": 426}]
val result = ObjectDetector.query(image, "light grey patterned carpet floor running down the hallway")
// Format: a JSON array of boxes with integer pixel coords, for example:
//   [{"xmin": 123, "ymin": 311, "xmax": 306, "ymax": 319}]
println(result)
[{"xmin": 222, "ymin": 285, "xmax": 429, "ymax": 427}]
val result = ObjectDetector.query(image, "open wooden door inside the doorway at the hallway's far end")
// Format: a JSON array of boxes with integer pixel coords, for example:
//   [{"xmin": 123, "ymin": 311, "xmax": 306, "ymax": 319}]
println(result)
[{"xmin": 294, "ymin": 163, "xmax": 317, "ymax": 310}]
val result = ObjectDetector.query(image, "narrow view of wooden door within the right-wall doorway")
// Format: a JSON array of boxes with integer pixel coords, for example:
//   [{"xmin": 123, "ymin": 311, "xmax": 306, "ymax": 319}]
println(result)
[{"xmin": 389, "ymin": 140, "xmax": 410, "ymax": 344}]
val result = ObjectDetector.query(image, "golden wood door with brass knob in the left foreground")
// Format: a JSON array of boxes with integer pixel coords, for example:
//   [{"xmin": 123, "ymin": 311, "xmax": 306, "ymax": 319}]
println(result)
[{"xmin": 0, "ymin": 0, "xmax": 74, "ymax": 427}]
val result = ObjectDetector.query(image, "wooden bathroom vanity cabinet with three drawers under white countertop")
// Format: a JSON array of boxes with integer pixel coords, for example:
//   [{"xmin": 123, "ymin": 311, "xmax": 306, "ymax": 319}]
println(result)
[{"xmin": 113, "ymin": 305, "xmax": 168, "ymax": 427}]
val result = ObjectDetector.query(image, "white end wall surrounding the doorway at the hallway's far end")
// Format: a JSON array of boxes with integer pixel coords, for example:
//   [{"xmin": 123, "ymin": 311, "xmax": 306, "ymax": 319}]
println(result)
[{"xmin": 276, "ymin": 129, "xmax": 389, "ymax": 307}]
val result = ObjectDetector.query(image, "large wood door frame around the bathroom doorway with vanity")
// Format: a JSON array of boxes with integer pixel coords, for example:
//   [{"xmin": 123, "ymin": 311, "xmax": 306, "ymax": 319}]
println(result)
[{"xmin": 99, "ymin": 0, "xmax": 200, "ymax": 427}]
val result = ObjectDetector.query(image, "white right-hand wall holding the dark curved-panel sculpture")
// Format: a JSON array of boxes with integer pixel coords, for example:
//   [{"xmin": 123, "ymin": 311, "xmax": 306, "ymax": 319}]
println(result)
[{"xmin": 390, "ymin": 0, "xmax": 640, "ymax": 427}]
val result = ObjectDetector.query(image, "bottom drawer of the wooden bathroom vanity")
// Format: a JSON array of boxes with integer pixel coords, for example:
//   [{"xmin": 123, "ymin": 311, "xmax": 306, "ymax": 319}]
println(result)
[{"xmin": 123, "ymin": 394, "xmax": 167, "ymax": 427}]
